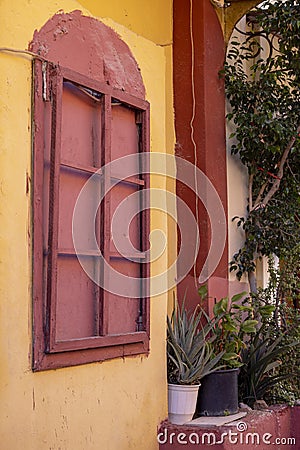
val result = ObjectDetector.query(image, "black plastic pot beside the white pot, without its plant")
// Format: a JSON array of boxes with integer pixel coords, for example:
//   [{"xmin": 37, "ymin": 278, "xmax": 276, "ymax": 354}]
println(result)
[{"xmin": 196, "ymin": 369, "xmax": 239, "ymax": 417}]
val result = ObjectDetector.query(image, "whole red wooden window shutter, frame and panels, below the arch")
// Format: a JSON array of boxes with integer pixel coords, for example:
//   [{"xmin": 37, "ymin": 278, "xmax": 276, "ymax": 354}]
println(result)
[{"xmin": 33, "ymin": 61, "xmax": 149, "ymax": 370}]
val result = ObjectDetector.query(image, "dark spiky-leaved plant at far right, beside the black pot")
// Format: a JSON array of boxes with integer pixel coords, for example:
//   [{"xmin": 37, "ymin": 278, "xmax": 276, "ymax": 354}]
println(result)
[{"xmin": 239, "ymin": 292, "xmax": 300, "ymax": 407}]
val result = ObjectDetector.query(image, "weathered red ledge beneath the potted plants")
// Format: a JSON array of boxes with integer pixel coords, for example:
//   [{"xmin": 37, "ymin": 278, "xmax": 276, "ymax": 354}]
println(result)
[{"xmin": 158, "ymin": 405, "xmax": 300, "ymax": 450}]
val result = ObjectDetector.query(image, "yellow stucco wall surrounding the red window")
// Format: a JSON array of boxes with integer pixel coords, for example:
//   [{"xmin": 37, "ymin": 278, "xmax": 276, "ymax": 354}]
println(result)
[{"xmin": 0, "ymin": 0, "xmax": 174, "ymax": 450}]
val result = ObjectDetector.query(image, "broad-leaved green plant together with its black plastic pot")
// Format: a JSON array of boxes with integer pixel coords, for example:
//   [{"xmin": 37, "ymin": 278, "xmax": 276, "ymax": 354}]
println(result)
[{"xmin": 197, "ymin": 288, "xmax": 258, "ymax": 416}]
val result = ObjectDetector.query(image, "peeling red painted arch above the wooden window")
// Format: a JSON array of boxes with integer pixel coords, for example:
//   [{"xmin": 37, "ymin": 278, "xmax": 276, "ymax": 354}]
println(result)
[{"xmin": 30, "ymin": 11, "xmax": 145, "ymax": 99}]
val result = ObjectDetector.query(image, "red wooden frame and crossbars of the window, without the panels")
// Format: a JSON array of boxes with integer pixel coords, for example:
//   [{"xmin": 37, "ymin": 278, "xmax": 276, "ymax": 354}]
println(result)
[{"xmin": 32, "ymin": 61, "xmax": 150, "ymax": 371}]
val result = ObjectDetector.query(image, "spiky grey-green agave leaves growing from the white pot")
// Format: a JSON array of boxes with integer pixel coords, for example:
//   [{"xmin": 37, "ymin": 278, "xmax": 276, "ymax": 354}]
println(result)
[{"xmin": 167, "ymin": 301, "xmax": 224, "ymax": 385}]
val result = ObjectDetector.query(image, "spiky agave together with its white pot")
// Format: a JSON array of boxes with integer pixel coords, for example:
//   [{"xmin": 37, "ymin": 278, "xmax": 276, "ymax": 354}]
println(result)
[{"xmin": 167, "ymin": 301, "xmax": 224, "ymax": 425}]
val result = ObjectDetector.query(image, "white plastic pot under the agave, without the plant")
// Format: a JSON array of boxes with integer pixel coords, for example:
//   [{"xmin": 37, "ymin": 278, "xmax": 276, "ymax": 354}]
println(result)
[{"xmin": 168, "ymin": 384, "xmax": 200, "ymax": 425}]
